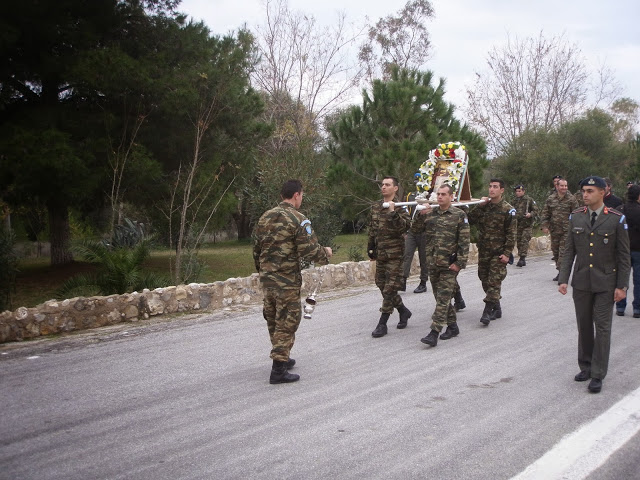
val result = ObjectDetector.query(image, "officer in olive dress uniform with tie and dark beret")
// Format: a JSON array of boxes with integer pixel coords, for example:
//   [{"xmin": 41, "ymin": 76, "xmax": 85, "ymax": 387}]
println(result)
[{"xmin": 558, "ymin": 177, "xmax": 631, "ymax": 393}]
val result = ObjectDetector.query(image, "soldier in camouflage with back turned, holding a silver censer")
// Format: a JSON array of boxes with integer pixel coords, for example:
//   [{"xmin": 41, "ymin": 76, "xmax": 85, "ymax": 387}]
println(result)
[{"xmin": 253, "ymin": 180, "xmax": 333, "ymax": 383}]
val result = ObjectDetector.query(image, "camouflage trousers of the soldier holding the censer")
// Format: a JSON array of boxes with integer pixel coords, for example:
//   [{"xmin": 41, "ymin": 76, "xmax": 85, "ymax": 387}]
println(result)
[{"xmin": 262, "ymin": 288, "xmax": 302, "ymax": 362}]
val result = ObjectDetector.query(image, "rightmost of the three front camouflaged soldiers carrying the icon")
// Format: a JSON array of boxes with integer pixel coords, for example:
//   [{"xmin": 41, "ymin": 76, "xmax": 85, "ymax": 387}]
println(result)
[{"xmin": 469, "ymin": 178, "xmax": 516, "ymax": 325}]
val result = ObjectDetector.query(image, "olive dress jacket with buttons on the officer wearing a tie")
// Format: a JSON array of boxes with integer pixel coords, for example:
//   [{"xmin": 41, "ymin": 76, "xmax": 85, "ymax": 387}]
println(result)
[{"xmin": 558, "ymin": 207, "xmax": 631, "ymax": 290}]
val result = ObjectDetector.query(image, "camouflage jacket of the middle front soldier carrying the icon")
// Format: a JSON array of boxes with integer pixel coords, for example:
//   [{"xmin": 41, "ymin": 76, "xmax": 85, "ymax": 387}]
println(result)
[{"xmin": 411, "ymin": 207, "xmax": 470, "ymax": 269}]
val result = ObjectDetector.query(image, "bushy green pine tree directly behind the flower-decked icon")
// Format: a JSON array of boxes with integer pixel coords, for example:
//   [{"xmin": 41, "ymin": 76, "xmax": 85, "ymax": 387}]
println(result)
[{"xmin": 328, "ymin": 67, "xmax": 486, "ymax": 216}]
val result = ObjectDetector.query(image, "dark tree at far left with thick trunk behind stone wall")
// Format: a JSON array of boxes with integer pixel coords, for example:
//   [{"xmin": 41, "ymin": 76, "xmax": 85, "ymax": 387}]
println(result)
[{"xmin": 0, "ymin": 0, "xmax": 176, "ymax": 265}]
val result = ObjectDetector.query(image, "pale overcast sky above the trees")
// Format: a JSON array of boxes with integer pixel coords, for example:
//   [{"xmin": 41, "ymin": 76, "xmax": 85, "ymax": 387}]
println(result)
[{"xmin": 178, "ymin": 0, "xmax": 640, "ymax": 117}]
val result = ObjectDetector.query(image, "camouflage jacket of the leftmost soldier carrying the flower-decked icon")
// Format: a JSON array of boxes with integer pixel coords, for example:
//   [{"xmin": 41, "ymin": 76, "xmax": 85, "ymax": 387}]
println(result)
[{"xmin": 368, "ymin": 201, "xmax": 411, "ymax": 260}]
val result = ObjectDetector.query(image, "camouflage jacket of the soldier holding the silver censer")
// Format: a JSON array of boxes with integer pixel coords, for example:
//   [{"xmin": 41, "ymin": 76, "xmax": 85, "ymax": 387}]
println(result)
[{"xmin": 253, "ymin": 202, "xmax": 329, "ymax": 288}]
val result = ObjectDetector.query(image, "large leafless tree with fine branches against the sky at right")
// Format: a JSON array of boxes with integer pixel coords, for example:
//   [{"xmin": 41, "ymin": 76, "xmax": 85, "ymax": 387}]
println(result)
[{"xmin": 466, "ymin": 33, "xmax": 613, "ymax": 155}]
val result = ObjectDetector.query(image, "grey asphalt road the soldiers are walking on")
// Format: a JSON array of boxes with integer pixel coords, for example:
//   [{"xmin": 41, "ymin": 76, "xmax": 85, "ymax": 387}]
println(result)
[{"xmin": 0, "ymin": 253, "xmax": 640, "ymax": 480}]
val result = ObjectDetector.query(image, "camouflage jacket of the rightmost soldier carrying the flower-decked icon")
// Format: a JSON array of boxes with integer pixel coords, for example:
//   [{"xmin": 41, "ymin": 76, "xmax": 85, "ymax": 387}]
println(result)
[{"xmin": 469, "ymin": 200, "xmax": 516, "ymax": 257}]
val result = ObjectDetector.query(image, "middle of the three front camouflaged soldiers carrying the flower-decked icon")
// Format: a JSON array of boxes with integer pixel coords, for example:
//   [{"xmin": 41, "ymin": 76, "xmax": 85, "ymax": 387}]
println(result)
[{"xmin": 411, "ymin": 184, "xmax": 470, "ymax": 347}]
